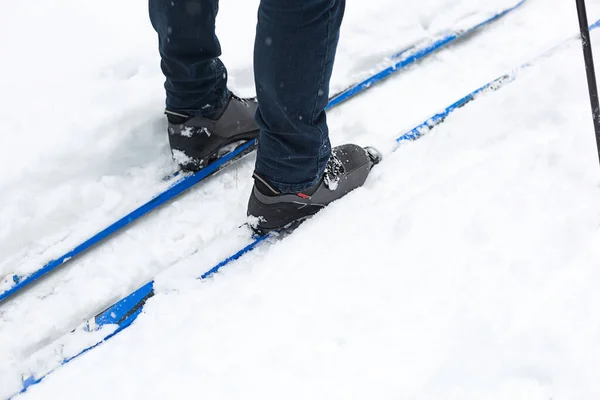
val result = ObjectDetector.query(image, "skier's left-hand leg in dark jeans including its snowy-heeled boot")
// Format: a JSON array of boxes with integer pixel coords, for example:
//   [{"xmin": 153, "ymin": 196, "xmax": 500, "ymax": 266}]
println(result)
[{"xmin": 149, "ymin": 0, "xmax": 259, "ymax": 171}]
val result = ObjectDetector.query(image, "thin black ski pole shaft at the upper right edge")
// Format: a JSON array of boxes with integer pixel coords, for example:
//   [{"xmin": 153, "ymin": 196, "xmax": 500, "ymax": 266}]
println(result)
[{"xmin": 575, "ymin": 0, "xmax": 600, "ymax": 164}]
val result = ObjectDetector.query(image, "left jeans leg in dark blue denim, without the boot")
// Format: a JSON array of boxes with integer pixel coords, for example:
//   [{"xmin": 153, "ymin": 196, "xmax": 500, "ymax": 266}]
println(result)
[{"xmin": 149, "ymin": 0, "xmax": 229, "ymax": 117}]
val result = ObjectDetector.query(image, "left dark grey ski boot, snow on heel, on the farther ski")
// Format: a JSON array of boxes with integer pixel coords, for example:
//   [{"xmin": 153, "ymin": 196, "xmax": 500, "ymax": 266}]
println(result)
[{"xmin": 165, "ymin": 94, "xmax": 259, "ymax": 172}]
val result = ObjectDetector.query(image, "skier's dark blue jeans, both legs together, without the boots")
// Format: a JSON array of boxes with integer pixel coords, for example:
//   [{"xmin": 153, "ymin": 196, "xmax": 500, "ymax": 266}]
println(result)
[{"xmin": 149, "ymin": 0, "xmax": 345, "ymax": 193}]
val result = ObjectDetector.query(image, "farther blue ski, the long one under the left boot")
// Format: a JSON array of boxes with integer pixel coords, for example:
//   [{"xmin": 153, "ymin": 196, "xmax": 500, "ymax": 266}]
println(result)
[{"xmin": 0, "ymin": 0, "xmax": 526, "ymax": 303}]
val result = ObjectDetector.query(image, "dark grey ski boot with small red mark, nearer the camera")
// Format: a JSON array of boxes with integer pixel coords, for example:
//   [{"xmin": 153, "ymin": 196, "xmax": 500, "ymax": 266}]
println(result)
[{"xmin": 248, "ymin": 144, "xmax": 381, "ymax": 235}]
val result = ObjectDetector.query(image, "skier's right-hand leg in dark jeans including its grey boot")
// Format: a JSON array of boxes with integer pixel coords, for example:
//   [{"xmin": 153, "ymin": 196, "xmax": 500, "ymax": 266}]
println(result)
[{"xmin": 248, "ymin": 0, "xmax": 381, "ymax": 234}]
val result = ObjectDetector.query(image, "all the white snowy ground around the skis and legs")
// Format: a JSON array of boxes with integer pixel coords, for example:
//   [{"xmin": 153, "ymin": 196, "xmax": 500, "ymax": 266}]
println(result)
[{"xmin": 0, "ymin": 0, "xmax": 600, "ymax": 400}]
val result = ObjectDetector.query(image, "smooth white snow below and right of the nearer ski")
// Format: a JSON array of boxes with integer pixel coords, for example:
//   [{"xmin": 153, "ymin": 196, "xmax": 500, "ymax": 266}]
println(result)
[{"xmin": 14, "ymin": 14, "xmax": 600, "ymax": 400}]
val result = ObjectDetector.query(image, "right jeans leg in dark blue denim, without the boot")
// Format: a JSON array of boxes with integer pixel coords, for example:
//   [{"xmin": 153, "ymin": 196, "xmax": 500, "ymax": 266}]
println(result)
[{"xmin": 254, "ymin": 0, "xmax": 345, "ymax": 193}]
